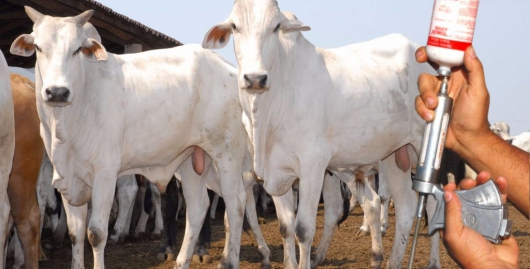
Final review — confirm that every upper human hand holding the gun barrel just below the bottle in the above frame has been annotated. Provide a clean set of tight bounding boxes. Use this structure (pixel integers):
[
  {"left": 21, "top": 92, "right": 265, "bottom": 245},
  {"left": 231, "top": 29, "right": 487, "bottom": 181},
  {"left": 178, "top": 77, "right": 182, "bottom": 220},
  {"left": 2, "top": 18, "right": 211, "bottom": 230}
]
[{"left": 416, "top": 46, "right": 493, "bottom": 156}]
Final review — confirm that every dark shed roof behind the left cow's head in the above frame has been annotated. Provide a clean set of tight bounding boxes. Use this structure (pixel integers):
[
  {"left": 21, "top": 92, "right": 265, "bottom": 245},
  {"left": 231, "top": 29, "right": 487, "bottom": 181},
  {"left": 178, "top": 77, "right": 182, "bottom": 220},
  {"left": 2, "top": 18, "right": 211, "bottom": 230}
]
[{"left": 0, "top": 0, "right": 182, "bottom": 68}]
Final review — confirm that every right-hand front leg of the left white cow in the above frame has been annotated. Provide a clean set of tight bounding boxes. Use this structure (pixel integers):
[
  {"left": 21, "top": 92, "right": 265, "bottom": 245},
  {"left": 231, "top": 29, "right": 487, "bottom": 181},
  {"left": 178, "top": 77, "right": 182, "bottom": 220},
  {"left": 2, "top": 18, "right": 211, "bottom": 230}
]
[{"left": 87, "top": 173, "right": 116, "bottom": 269}]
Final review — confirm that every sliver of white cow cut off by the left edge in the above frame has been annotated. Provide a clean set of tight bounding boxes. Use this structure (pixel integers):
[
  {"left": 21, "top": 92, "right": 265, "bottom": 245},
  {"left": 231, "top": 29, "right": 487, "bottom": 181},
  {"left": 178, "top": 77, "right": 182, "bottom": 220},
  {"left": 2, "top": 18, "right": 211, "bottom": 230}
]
[{"left": 0, "top": 49, "right": 15, "bottom": 268}]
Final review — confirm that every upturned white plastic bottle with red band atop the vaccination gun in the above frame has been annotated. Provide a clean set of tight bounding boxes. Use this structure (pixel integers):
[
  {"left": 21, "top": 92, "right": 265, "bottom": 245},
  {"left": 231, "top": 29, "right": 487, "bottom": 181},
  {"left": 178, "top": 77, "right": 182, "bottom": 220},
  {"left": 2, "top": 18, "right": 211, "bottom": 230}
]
[{"left": 427, "top": 0, "right": 479, "bottom": 74}]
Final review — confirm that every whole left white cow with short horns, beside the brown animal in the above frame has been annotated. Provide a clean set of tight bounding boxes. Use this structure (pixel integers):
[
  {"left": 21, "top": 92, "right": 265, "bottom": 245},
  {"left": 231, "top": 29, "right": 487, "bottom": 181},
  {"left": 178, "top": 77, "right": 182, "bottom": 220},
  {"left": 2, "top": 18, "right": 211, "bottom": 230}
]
[{"left": 11, "top": 7, "right": 247, "bottom": 268}]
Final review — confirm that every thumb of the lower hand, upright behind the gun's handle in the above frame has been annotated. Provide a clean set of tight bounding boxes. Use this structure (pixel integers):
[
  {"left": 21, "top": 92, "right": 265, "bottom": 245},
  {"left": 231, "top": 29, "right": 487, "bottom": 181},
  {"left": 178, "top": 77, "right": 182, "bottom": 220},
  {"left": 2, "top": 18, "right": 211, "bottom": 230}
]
[{"left": 444, "top": 189, "right": 464, "bottom": 242}]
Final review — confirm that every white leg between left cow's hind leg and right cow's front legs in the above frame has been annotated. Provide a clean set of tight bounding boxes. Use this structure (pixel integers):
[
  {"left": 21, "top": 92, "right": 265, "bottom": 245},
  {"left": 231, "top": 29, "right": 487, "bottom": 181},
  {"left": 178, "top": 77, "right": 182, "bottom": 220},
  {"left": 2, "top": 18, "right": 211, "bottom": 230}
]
[{"left": 245, "top": 181, "right": 271, "bottom": 269}]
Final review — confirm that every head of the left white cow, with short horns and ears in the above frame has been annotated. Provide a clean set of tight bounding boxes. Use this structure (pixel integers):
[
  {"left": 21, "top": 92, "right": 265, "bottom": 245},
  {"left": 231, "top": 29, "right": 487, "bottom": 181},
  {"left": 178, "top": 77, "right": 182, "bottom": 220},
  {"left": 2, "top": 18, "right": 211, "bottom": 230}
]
[{"left": 11, "top": 6, "right": 107, "bottom": 106}]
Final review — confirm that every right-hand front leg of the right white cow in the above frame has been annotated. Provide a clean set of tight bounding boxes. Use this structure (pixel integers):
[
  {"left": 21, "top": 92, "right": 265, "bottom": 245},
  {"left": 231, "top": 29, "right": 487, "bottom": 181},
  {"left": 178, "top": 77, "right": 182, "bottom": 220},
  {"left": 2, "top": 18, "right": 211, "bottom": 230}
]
[{"left": 295, "top": 165, "right": 326, "bottom": 268}]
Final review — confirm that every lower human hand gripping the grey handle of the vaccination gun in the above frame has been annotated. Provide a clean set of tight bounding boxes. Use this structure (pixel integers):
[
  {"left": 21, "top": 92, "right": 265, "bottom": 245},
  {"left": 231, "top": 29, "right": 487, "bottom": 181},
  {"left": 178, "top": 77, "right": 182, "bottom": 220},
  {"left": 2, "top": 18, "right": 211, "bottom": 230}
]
[{"left": 440, "top": 172, "right": 519, "bottom": 269}]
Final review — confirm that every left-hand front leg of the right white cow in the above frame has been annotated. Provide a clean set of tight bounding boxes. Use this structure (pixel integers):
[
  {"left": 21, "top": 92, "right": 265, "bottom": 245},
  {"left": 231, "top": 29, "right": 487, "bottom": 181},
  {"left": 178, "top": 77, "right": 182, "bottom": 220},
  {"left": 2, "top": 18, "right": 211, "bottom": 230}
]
[{"left": 272, "top": 188, "right": 298, "bottom": 269}]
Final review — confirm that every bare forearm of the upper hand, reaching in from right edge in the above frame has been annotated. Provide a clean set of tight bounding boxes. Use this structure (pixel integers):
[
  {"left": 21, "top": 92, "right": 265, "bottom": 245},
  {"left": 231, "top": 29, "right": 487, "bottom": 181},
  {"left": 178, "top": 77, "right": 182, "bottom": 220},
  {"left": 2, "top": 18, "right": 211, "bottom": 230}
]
[{"left": 455, "top": 132, "right": 530, "bottom": 218}]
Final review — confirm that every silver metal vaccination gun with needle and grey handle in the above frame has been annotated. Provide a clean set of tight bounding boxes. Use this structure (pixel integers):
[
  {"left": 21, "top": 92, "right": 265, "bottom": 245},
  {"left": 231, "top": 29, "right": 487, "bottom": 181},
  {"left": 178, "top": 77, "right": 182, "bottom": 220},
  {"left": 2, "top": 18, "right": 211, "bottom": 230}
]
[{"left": 409, "top": 69, "right": 511, "bottom": 268}]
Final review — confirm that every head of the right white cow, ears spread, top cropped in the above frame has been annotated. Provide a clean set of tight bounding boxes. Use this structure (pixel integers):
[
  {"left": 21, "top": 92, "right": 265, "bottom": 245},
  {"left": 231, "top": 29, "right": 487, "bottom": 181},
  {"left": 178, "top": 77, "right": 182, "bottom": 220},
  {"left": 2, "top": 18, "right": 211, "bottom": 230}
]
[{"left": 202, "top": 0, "right": 310, "bottom": 93}]
